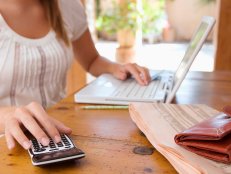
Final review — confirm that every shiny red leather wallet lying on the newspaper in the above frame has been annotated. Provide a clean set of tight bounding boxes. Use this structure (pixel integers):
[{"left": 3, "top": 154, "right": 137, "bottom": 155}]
[{"left": 174, "top": 106, "right": 231, "bottom": 163}]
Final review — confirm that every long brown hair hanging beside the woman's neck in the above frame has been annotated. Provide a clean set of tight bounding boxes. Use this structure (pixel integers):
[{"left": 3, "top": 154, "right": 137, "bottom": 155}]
[{"left": 41, "top": 0, "right": 70, "bottom": 46}]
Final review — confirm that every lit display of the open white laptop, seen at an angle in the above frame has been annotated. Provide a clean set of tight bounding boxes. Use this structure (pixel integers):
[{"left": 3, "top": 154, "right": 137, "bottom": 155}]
[{"left": 173, "top": 22, "right": 208, "bottom": 84}]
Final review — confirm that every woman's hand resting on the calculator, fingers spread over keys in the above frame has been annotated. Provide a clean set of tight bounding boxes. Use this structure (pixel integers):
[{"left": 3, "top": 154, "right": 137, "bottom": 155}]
[{"left": 3, "top": 102, "right": 71, "bottom": 149}]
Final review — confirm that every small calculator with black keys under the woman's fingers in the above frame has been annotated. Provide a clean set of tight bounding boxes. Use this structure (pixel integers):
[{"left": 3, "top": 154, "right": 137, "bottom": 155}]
[{"left": 28, "top": 134, "right": 85, "bottom": 166}]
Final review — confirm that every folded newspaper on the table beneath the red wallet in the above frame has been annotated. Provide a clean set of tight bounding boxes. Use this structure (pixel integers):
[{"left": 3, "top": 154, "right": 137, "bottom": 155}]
[{"left": 129, "top": 103, "right": 231, "bottom": 174}]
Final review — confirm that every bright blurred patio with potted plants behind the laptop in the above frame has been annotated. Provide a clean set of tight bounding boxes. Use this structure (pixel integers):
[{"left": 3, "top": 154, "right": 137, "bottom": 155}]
[{"left": 68, "top": 0, "right": 222, "bottom": 94}]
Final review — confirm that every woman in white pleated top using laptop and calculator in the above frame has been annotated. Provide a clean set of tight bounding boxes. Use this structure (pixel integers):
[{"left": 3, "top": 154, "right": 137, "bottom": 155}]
[{"left": 0, "top": 0, "right": 150, "bottom": 149}]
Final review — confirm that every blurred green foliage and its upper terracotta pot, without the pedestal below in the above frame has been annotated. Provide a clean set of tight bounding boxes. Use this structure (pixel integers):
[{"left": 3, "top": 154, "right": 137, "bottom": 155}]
[{"left": 96, "top": 0, "right": 141, "bottom": 47}]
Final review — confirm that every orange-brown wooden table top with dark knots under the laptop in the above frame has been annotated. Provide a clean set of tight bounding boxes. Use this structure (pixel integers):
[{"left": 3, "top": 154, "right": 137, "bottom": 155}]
[{"left": 0, "top": 72, "right": 231, "bottom": 174}]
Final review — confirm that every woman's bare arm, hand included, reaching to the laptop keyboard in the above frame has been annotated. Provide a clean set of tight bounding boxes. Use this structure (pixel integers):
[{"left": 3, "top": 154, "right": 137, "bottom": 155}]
[{"left": 72, "top": 30, "right": 150, "bottom": 85}]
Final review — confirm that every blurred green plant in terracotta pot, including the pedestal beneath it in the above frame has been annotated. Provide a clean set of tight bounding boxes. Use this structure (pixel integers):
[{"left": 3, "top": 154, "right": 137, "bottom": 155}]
[{"left": 96, "top": 0, "right": 141, "bottom": 63}]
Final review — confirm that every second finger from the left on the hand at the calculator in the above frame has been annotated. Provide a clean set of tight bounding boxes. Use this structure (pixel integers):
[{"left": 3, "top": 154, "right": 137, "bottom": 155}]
[{"left": 7, "top": 119, "right": 31, "bottom": 150}]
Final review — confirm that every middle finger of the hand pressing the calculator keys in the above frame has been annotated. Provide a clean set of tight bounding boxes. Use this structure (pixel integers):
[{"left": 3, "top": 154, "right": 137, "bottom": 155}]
[{"left": 15, "top": 108, "right": 49, "bottom": 146}]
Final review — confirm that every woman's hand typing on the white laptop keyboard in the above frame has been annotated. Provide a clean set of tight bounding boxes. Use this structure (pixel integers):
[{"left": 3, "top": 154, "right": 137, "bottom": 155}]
[{"left": 112, "top": 63, "right": 151, "bottom": 85}]
